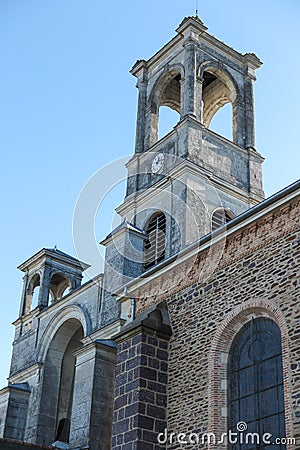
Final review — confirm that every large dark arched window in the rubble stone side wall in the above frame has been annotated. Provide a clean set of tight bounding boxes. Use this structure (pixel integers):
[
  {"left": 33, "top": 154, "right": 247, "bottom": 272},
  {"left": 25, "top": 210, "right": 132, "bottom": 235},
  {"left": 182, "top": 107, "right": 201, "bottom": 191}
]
[{"left": 228, "top": 318, "right": 286, "bottom": 450}]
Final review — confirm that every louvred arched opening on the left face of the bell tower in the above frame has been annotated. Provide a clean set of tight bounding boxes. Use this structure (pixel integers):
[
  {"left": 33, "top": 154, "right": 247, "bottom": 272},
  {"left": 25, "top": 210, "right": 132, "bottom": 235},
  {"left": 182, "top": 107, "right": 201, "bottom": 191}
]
[{"left": 144, "top": 213, "right": 166, "bottom": 270}]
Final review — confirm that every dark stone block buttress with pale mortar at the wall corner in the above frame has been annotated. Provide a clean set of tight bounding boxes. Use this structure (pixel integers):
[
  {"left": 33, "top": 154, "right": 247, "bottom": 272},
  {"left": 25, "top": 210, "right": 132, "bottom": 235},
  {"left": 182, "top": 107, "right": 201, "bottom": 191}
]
[{"left": 111, "top": 306, "right": 171, "bottom": 450}]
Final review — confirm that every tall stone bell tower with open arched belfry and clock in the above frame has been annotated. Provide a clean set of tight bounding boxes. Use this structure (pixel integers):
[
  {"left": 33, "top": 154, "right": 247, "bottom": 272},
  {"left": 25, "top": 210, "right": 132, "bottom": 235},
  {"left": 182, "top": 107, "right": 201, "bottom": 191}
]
[{"left": 112, "top": 16, "right": 264, "bottom": 270}]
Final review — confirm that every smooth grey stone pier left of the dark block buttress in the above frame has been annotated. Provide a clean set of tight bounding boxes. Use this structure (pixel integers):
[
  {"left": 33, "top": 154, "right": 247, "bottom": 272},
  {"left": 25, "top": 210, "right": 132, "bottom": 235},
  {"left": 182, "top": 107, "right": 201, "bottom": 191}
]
[{"left": 70, "top": 340, "right": 117, "bottom": 450}]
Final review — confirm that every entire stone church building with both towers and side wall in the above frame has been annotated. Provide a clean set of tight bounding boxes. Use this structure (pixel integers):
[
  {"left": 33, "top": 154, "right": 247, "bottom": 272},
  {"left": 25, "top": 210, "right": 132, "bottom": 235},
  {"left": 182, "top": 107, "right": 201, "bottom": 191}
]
[{"left": 0, "top": 12, "right": 300, "bottom": 450}]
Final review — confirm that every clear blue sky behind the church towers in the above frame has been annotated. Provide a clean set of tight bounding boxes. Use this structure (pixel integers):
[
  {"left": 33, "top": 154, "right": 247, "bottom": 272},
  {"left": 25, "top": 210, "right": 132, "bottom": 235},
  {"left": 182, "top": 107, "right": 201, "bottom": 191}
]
[{"left": 0, "top": 0, "right": 300, "bottom": 386}]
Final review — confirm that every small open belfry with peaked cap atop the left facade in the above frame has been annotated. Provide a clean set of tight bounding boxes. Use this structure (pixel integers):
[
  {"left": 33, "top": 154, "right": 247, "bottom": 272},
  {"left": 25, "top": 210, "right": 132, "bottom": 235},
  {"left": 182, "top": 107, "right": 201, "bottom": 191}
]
[{"left": 18, "top": 247, "right": 89, "bottom": 317}]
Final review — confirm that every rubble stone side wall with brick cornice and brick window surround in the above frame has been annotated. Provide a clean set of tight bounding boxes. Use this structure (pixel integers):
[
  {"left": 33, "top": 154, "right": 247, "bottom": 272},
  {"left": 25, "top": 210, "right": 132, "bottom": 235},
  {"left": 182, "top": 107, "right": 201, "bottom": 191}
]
[{"left": 127, "top": 197, "right": 300, "bottom": 449}]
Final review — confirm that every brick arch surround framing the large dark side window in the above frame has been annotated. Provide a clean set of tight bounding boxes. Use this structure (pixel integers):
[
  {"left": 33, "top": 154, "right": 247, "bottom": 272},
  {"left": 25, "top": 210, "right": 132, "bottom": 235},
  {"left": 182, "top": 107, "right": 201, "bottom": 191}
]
[{"left": 208, "top": 299, "right": 293, "bottom": 449}]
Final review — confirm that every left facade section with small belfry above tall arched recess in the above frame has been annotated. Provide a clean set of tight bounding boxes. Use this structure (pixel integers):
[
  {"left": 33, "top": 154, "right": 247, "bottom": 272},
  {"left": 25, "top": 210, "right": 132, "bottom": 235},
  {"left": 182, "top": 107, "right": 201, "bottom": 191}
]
[{"left": 0, "top": 247, "right": 89, "bottom": 444}]
